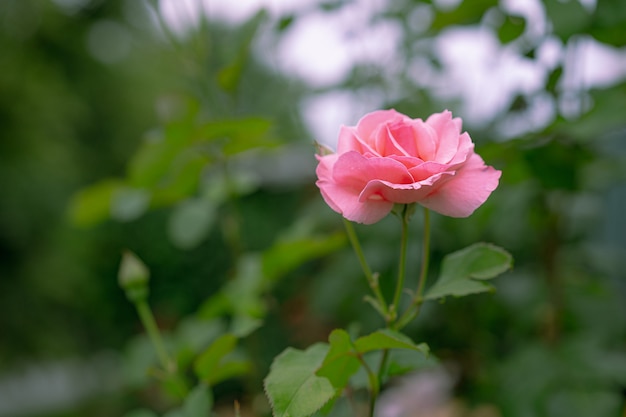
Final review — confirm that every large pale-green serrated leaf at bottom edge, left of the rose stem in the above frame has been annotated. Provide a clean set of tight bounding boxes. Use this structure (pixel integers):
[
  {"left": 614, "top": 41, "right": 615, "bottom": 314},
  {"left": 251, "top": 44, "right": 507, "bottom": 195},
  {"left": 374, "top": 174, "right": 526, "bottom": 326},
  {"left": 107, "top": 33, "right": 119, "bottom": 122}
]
[{"left": 264, "top": 343, "right": 335, "bottom": 417}]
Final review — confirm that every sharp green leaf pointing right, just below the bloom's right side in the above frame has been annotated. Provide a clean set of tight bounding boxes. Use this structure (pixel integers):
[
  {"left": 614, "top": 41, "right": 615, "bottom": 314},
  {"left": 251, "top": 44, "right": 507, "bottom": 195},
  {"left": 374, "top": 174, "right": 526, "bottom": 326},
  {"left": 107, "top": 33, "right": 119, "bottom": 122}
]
[{"left": 424, "top": 243, "right": 513, "bottom": 300}]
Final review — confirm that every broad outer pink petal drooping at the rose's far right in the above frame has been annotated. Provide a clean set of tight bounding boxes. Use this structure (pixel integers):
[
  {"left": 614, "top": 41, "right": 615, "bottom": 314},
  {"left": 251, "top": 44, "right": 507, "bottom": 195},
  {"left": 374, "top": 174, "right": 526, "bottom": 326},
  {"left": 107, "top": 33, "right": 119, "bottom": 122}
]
[{"left": 419, "top": 154, "right": 502, "bottom": 217}]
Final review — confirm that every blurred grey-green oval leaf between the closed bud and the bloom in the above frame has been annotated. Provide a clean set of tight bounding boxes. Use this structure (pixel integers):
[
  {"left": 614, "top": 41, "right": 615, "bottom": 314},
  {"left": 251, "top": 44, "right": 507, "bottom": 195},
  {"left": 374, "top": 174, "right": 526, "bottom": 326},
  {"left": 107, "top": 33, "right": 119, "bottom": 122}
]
[{"left": 168, "top": 199, "right": 217, "bottom": 249}]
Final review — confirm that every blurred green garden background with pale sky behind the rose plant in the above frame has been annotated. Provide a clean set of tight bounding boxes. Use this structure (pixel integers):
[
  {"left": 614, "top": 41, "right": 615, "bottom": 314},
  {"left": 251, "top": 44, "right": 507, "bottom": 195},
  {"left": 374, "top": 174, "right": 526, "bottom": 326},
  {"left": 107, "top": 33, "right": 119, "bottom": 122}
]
[{"left": 0, "top": 0, "right": 626, "bottom": 417}]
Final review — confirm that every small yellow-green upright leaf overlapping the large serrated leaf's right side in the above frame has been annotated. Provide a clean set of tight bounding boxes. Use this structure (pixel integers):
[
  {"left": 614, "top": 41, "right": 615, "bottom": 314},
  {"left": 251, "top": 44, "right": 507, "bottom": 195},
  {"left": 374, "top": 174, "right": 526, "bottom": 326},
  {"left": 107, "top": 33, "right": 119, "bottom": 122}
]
[{"left": 316, "top": 329, "right": 361, "bottom": 390}]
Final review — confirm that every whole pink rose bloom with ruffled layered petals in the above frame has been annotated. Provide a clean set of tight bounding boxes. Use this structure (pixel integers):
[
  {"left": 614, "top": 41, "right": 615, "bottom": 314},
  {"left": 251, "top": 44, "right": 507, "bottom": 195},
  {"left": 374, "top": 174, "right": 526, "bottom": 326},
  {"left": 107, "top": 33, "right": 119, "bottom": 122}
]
[{"left": 316, "top": 110, "right": 501, "bottom": 224}]
